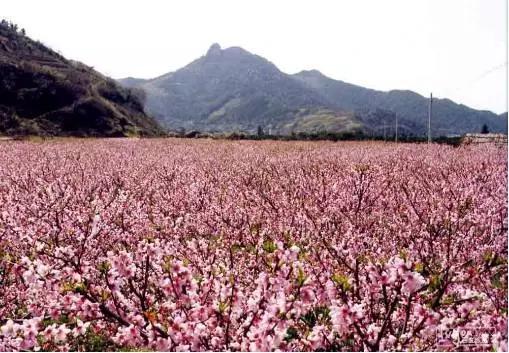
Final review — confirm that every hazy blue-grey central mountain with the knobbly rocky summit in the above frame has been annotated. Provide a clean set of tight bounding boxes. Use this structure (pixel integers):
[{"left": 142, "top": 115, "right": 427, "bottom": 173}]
[{"left": 120, "top": 44, "right": 361, "bottom": 134}]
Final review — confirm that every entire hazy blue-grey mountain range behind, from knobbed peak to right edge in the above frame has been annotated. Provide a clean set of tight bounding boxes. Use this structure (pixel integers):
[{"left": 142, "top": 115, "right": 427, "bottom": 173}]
[{"left": 120, "top": 44, "right": 507, "bottom": 136}]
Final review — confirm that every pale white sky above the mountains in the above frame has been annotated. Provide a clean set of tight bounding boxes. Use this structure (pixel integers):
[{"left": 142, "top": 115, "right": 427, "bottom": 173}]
[{"left": 0, "top": 0, "right": 507, "bottom": 113}]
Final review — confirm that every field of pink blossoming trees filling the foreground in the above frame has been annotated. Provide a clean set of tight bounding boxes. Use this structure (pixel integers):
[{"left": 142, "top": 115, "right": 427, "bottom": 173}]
[{"left": 0, "top": 139, "right": 508, "bottom": 351}]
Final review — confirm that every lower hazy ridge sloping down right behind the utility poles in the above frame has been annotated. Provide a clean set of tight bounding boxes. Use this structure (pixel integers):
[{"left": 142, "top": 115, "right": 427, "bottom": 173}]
[{"left": 293, "top": 70, "right": 507, "bottom": 136}]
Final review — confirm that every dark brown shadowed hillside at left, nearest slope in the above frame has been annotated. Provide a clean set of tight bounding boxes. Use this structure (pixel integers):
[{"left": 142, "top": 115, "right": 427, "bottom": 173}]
[{"left": 0, "top": 20, "right": 162, "bottom": 136}]
